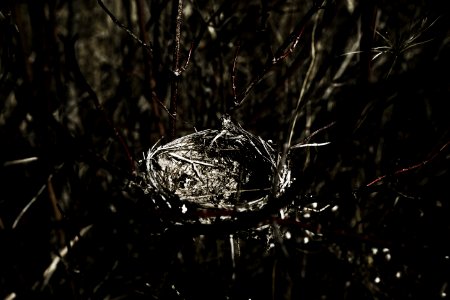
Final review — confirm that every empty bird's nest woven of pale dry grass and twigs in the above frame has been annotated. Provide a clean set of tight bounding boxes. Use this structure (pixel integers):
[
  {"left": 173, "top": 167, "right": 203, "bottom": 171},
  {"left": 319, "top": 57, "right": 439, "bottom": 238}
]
[{"left": 146, "top": 116, "right": 287, "bottom": 210}]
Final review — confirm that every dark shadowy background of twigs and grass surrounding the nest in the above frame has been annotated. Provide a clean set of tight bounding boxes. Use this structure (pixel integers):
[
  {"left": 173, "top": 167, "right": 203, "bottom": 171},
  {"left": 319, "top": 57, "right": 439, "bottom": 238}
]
[{"left": 0, "top": 0, "right": 450, "bottom": 299}]
